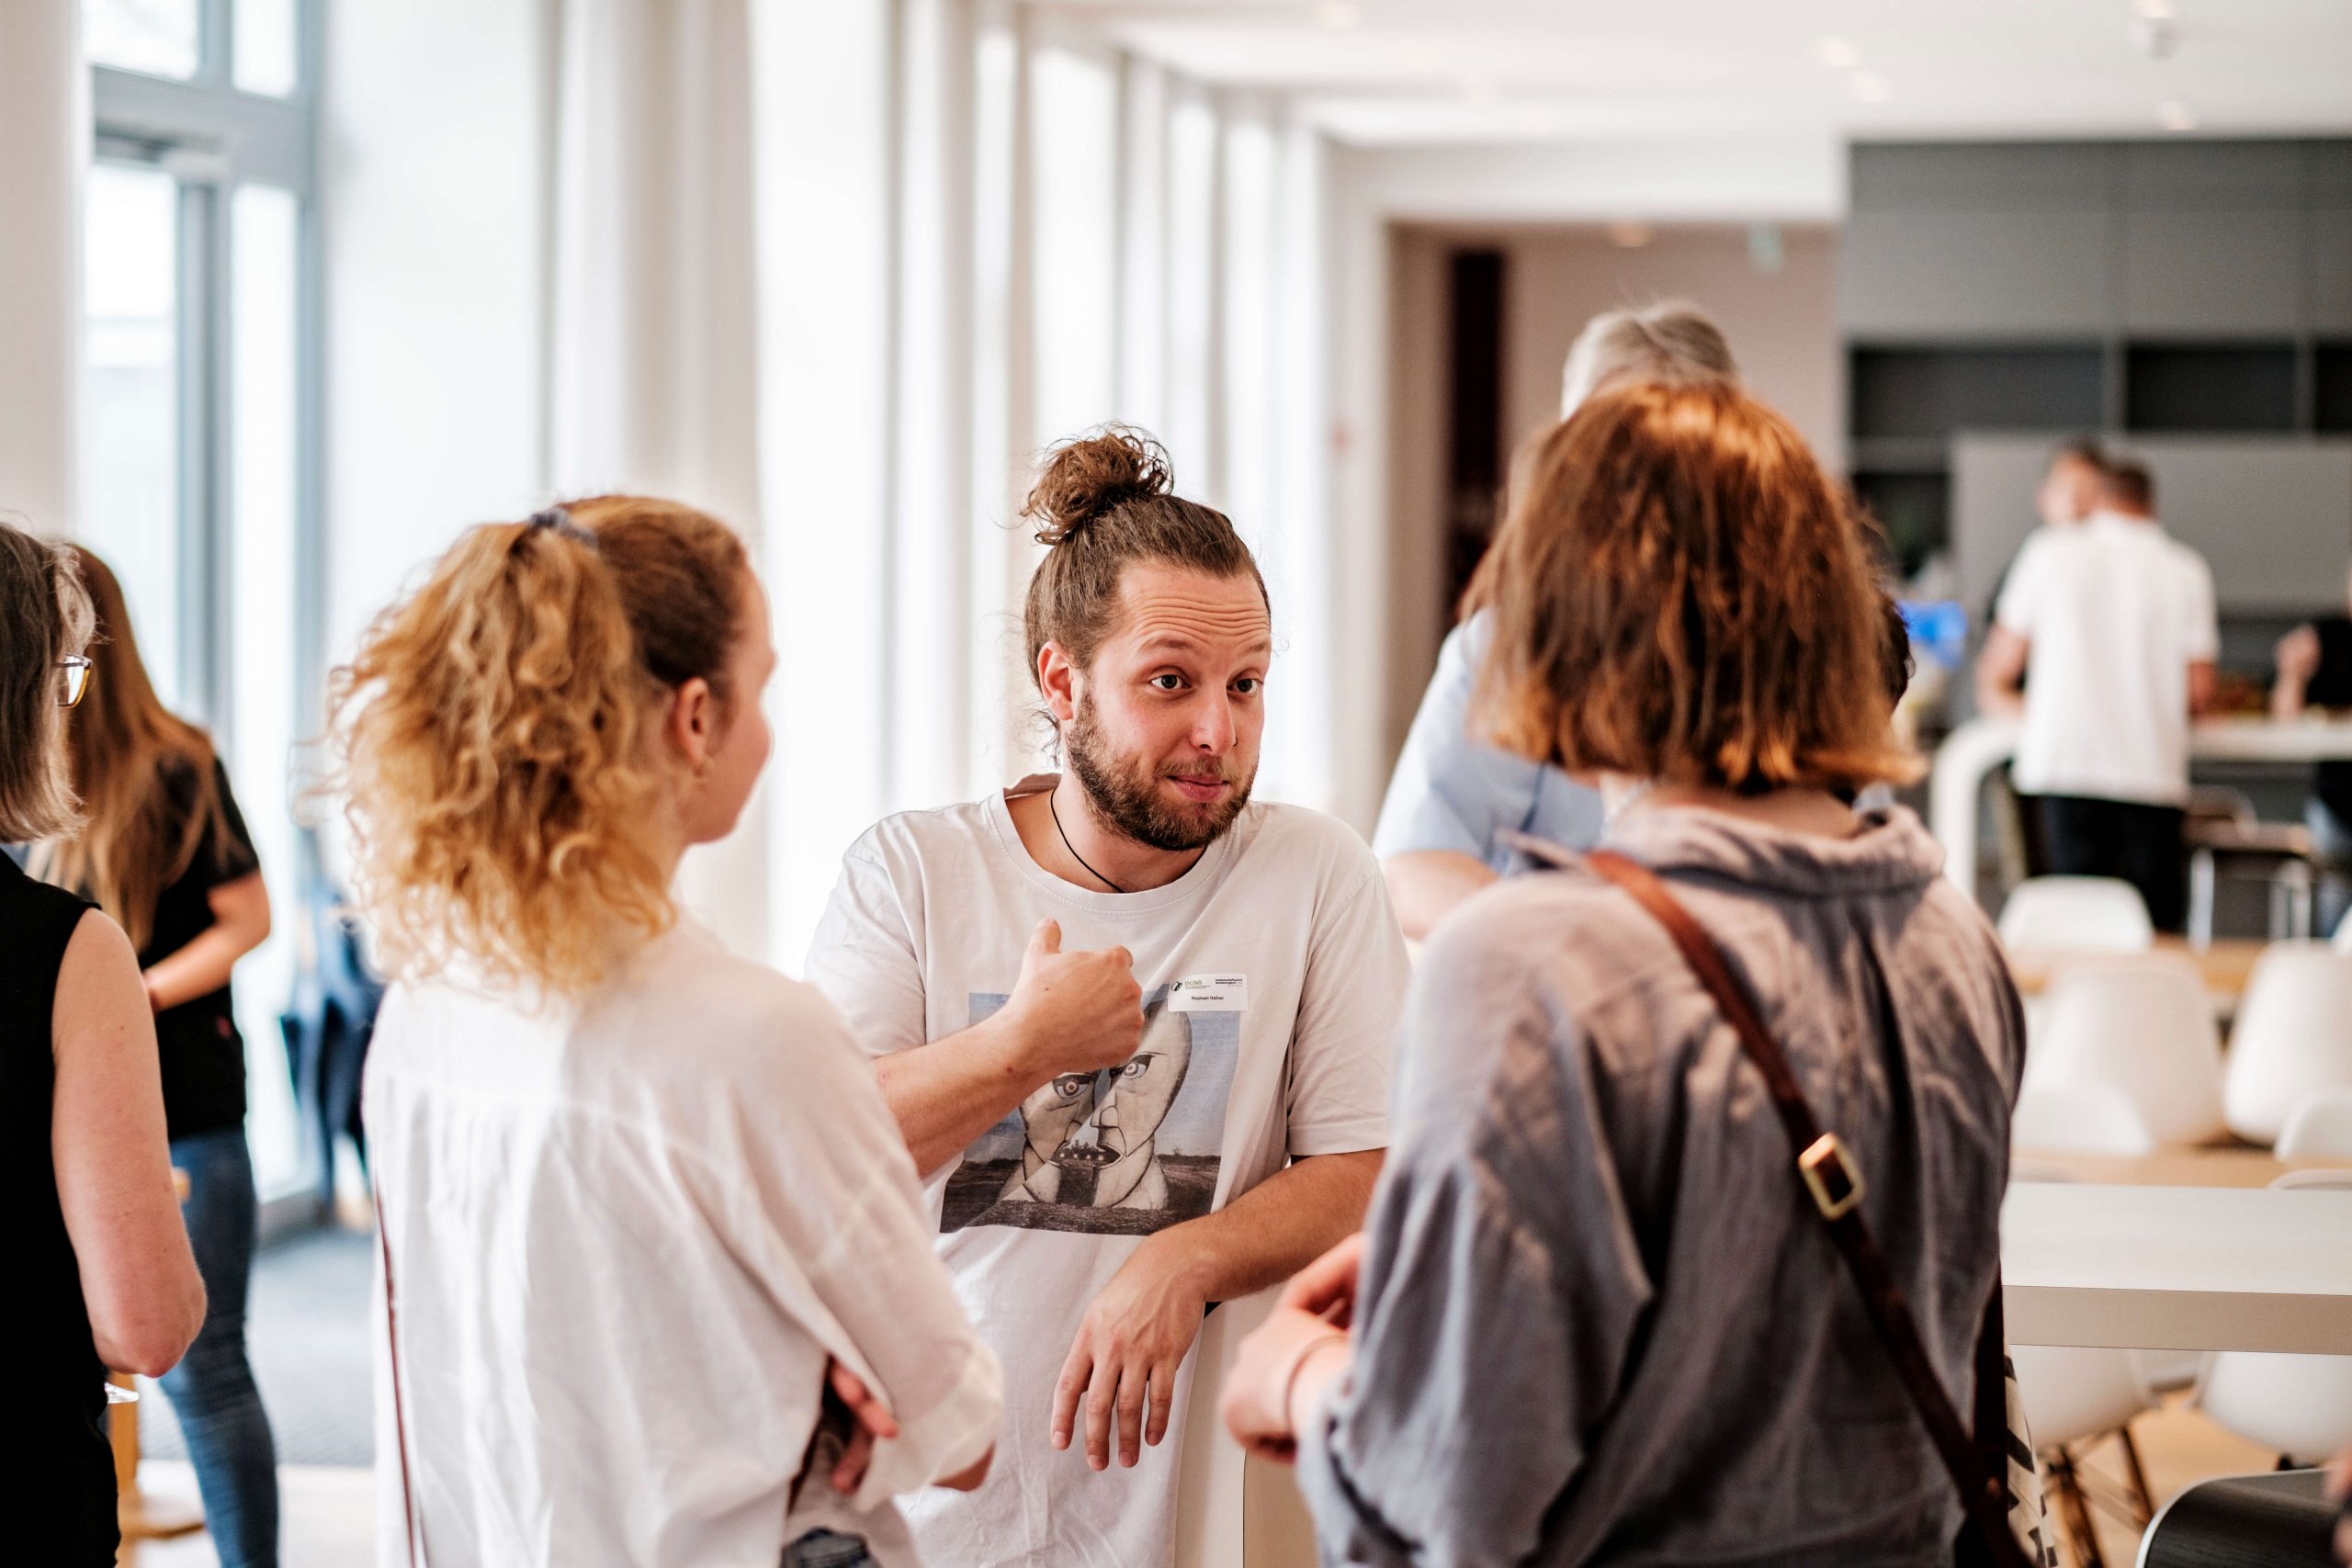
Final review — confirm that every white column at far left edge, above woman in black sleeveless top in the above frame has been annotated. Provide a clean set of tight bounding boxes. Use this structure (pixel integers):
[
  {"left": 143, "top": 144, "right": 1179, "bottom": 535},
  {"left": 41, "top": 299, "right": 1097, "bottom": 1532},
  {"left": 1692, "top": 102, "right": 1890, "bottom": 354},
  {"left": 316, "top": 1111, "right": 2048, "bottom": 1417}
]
[{"left": 0, "top": 0, "right": 89, "bottom": 534}]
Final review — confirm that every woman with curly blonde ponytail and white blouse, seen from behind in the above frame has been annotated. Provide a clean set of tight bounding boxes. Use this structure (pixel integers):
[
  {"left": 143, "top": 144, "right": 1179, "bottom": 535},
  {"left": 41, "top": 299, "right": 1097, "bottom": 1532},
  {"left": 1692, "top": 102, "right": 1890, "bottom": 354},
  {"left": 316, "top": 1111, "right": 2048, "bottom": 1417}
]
[{"left": 334, "top": 496, "right": 1000, "bottom": 1568}]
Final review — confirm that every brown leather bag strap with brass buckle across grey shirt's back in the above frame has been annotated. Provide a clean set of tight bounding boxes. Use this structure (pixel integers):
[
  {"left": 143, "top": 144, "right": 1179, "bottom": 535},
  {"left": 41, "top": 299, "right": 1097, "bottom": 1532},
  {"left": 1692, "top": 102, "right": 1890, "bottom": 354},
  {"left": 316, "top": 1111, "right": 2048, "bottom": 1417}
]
[{"left": 1585, "top": 849, "right": 2030, "bottom": 1568}]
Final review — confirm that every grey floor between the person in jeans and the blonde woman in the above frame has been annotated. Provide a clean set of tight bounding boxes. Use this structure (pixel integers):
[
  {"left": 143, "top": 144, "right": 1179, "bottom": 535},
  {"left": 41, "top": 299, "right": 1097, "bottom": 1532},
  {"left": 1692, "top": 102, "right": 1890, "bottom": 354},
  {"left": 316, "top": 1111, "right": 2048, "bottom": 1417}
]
[{"left": 139, "top": 1229, "right": 377, "bottom": 1464}]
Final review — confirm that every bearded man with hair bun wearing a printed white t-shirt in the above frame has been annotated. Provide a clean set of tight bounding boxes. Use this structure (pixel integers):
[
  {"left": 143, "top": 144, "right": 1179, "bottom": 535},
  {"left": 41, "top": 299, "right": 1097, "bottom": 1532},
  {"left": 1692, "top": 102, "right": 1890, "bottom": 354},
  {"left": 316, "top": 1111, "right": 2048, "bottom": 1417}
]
[{"left": 809, "top": 428, "right": 1407, "bottom": 1568}]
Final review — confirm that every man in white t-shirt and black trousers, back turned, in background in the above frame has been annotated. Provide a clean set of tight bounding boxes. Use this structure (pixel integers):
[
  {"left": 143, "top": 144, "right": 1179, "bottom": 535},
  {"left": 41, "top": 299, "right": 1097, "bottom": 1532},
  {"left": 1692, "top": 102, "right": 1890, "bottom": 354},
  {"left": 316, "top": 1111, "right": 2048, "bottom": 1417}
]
[{"left": 1975, "top": 463, "right": 2221, "bottom": 931}]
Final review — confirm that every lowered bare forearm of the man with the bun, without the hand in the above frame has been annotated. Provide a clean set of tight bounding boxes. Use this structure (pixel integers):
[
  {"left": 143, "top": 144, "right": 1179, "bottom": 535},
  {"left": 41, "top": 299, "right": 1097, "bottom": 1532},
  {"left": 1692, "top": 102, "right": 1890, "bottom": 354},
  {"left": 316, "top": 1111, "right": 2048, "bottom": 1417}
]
[{"left": 1152, "top": 1149, "right": 1383, "bottom": 1303}]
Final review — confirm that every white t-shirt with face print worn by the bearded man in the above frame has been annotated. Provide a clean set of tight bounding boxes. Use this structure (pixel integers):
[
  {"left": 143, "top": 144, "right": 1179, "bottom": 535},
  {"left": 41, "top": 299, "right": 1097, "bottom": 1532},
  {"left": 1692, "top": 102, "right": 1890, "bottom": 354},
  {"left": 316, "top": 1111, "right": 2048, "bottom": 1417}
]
[{"left": 809, "top": 776, "right": 1407, "bottom": 1568}]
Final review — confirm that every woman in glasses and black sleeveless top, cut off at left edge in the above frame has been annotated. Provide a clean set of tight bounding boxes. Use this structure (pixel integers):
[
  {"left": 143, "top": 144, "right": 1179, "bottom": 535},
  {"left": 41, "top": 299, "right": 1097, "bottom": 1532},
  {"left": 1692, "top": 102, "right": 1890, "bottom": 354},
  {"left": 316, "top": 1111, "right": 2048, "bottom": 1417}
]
[{"left": 0, "top": 522, "right": 205, "bottom": 1568}]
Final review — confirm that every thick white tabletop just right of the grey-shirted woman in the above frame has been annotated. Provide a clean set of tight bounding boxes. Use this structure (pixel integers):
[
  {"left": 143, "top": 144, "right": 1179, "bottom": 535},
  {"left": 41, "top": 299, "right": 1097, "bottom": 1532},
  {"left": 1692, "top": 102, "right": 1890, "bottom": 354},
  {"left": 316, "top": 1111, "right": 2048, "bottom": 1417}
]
[{"left": 2002, "top": 1182, "right": 2352, "bottom": 1357}]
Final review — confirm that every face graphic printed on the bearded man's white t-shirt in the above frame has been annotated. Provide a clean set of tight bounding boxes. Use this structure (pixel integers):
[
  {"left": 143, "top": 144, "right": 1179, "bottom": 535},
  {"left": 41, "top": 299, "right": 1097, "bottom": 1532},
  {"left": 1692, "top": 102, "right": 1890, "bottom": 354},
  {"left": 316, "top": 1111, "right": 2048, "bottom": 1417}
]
[{"left": 941, "top": 987, "right": 1242, "bottom": 1236}]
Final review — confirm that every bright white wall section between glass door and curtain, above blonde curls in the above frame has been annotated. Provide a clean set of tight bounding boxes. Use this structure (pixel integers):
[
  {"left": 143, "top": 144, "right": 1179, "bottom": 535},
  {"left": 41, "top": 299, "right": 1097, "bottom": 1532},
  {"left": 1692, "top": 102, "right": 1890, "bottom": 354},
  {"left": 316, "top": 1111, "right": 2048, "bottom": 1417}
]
[{"left": 320, "top": 0, "right": 548, "bottom": 660}]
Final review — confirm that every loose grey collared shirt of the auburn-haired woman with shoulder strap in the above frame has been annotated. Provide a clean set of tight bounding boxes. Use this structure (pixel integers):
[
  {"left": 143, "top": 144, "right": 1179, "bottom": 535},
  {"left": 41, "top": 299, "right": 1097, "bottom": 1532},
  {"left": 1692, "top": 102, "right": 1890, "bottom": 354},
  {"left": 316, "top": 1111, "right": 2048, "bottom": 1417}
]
[{"left": 1298, "top": 807, "right": 2025, "bottom": 1568}]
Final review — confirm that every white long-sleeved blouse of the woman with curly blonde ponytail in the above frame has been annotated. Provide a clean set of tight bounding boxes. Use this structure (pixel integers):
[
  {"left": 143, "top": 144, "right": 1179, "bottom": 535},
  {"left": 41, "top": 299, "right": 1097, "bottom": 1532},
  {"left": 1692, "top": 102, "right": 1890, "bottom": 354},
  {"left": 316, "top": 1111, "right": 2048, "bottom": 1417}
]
[{"left": 367, "top": 921, "right": 1002, "bottom": 1568}]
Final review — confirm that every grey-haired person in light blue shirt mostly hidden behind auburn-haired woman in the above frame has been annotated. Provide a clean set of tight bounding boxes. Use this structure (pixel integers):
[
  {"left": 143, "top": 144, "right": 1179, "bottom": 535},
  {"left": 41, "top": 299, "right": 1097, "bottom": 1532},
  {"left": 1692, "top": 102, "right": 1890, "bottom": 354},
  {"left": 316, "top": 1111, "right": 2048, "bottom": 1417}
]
[{"left": 1371, "top": 301, "right": 1738, "bottom": 941}]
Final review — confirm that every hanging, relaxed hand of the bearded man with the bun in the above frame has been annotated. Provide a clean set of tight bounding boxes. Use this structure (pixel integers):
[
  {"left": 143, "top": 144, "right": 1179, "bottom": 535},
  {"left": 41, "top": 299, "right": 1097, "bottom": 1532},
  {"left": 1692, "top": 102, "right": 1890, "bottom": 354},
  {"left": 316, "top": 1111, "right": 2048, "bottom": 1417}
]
[{"left": 1054, "top": 1232, "right": 1209, "bottom": 1470}]
